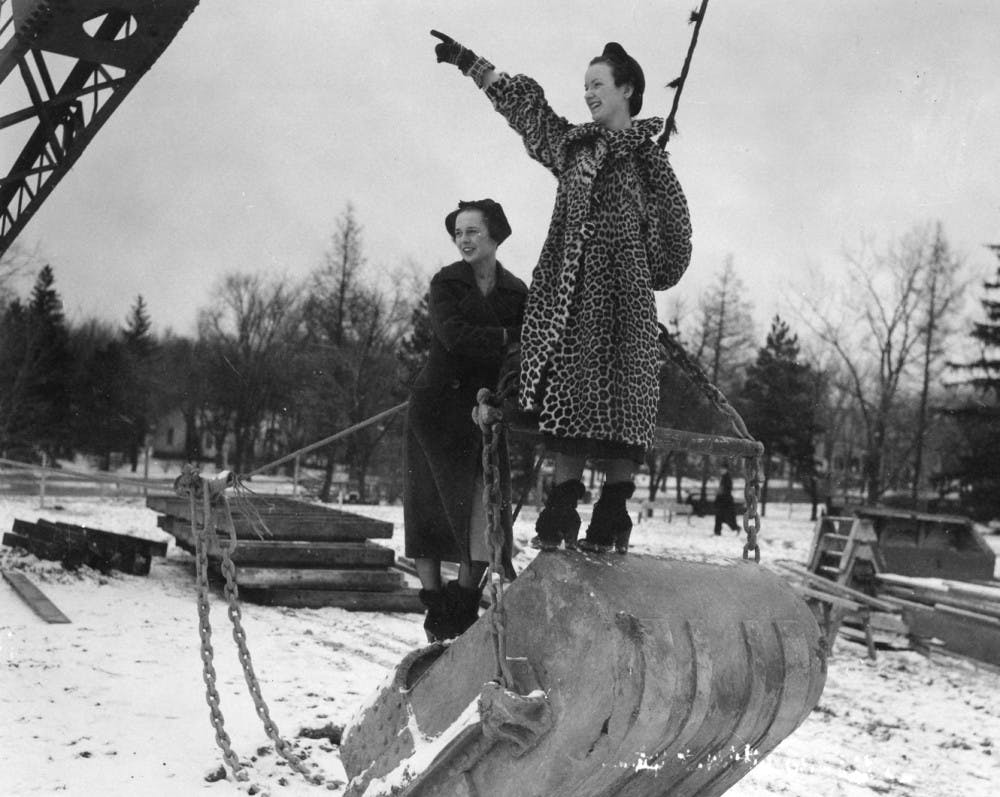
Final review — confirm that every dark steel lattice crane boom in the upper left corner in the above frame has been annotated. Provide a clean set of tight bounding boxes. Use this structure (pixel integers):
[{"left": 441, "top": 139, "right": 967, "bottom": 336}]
[{"left": 0, "top": 0, "right": 198, "bottom": 255}]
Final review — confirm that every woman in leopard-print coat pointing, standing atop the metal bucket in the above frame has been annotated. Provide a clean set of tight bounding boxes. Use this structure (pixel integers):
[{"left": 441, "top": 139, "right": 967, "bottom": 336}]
[{"left": 431, "top": 31, "right": 691, "bottom": 553}]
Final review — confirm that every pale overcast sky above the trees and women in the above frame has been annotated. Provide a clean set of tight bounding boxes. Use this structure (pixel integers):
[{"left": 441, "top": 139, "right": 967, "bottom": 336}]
[{"left": 2, "top": 0, "right": 1000, "bottom": 334}]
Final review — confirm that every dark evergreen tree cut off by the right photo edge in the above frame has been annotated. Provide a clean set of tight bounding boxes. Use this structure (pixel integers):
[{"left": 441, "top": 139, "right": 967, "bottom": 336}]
[{"left": 950, "top": 244, "right": 1000, "bottom": 521}]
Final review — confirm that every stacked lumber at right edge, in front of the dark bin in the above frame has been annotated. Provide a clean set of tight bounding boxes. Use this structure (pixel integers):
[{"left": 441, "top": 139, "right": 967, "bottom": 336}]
[{"left": 876, "top": 573, "right": 1000, "bottom": 665}]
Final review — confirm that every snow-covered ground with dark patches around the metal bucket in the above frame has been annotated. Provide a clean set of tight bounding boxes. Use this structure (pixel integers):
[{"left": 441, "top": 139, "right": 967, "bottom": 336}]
[{"left": 0, "top": 495, "right": 1000, "bottom": 797}]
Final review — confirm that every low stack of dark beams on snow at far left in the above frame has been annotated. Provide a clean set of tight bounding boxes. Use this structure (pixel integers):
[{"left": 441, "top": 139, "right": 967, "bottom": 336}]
[{"left": 3, "top": 519, "right": 167, "bottom": 576}]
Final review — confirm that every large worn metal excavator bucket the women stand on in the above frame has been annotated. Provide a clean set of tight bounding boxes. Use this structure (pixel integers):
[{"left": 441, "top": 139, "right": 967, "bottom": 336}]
[{"left": 341, "top": 552, "right": 826, "bottom": 797}]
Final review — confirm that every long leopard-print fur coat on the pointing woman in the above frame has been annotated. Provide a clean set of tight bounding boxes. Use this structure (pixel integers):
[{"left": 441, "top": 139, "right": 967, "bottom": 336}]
[{"left": 487, "top": 74, "right": 691, "bottom": 455}]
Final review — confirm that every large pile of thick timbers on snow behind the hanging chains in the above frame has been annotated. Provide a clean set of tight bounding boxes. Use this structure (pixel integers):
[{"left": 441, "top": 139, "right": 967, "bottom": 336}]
[{"left": 146, "top": 495, "right": 423, "bottom": 612}]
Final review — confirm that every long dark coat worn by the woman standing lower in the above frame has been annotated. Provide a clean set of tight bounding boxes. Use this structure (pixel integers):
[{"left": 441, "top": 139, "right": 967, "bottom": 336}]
[{"left": 403, "top": 261, "right": 528, "bottom": 575}]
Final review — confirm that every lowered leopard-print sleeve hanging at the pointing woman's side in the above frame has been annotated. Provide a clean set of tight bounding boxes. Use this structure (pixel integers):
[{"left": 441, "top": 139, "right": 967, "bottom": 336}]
[{"left": 643, "top": 142, "right": 691, "bottom": 291}]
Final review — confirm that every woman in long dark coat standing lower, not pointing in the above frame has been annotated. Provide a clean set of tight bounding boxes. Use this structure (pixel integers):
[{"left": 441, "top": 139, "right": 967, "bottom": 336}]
[{"left": 403, "top": 199, "right": 528, "bottom": 641}]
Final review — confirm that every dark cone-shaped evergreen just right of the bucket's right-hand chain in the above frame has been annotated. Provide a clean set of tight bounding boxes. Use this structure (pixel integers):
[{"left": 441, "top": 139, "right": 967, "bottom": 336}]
[{"left": 739, "top": 316, "right": 820, "bottom": 511}]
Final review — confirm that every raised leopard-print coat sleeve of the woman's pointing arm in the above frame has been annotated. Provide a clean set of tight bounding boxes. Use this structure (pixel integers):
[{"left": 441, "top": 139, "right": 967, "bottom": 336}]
[{"left": 486, "top": 74, "right": 572, "bottom": 177}]
